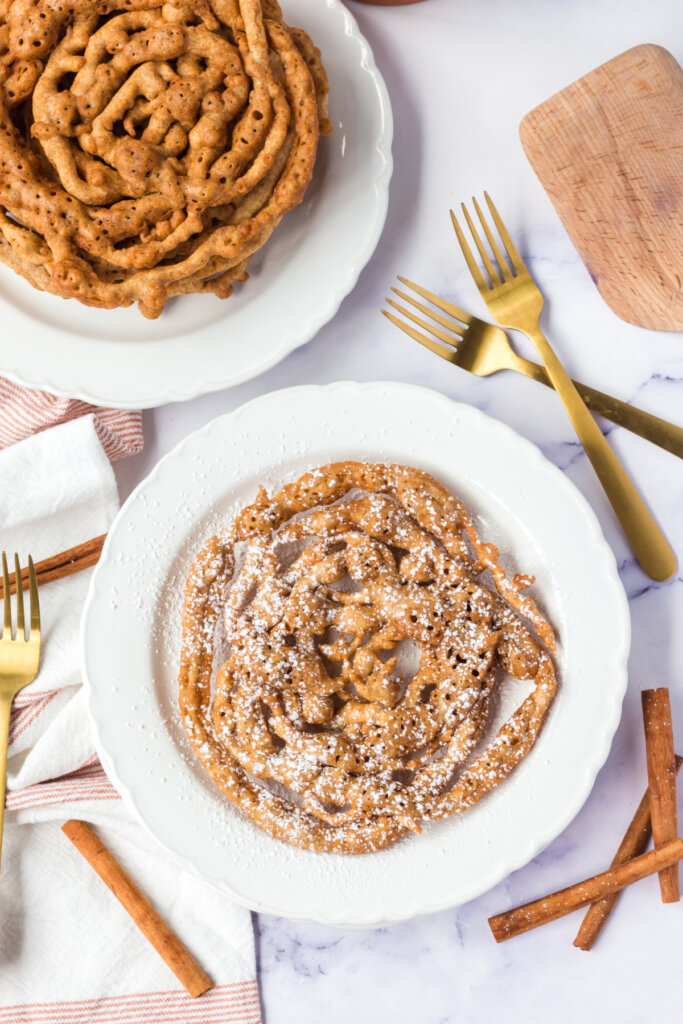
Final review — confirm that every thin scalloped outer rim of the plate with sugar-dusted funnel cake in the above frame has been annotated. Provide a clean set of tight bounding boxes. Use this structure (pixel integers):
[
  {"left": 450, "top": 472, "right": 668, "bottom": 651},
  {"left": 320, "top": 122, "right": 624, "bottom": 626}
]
[{"left": 80, "top": 380, "right": 631, "bottom": 929}]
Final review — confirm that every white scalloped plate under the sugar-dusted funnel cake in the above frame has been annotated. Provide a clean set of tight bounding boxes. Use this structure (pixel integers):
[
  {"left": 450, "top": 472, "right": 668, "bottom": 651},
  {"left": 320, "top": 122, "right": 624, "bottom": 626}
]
[{"left": 83, "top": 384, "right": 630, "bottom": 927}]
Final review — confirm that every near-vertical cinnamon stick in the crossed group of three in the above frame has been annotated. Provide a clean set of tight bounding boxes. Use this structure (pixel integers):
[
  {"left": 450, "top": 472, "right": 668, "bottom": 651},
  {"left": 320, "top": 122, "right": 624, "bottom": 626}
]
[{"left": 641, "top": 687, "right": 681, "bottom": 903}]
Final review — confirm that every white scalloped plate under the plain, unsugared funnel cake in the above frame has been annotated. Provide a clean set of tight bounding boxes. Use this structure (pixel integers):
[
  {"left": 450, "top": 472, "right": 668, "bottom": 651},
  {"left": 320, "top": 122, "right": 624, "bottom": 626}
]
[{"left": 0, "top": 0, "right": 392, "bottom": 409}]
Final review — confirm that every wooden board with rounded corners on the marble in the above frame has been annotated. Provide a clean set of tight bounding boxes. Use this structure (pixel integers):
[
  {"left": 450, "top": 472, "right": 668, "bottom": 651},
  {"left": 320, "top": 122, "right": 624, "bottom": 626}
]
[{"left": 520, "top": 44, "right": 683, "bottom": 331}]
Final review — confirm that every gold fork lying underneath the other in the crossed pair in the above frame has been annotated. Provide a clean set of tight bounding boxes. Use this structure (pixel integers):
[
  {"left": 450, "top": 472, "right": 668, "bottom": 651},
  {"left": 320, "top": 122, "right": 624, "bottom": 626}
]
[{"left": 382, "top": 275, "right": 683, "bottom": 459}]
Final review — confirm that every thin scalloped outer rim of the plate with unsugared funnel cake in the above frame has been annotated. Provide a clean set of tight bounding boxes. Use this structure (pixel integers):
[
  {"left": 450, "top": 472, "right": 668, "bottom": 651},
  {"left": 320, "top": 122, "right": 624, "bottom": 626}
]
[{"left": 1, "top": 0, "right": 393, "bottom": 410}]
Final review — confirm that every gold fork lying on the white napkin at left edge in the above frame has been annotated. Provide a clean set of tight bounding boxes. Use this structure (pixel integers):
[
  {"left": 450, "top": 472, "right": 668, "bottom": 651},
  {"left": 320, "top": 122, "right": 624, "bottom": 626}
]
[{"left": 0, "top": 551, "right": 40, "bottom": 858}]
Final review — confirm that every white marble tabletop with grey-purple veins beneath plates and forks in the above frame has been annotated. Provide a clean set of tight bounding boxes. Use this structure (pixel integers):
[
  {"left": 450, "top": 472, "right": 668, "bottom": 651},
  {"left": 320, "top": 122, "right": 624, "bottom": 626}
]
[{"left": 113, "top": 0, "right": 683, "bottom": 1024}]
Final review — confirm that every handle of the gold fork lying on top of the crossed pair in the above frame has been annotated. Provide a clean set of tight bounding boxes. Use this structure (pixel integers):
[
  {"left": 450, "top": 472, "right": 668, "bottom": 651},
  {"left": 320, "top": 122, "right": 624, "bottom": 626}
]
[{"left": 526, "top": 328, "right": 676, "bottom": 580}]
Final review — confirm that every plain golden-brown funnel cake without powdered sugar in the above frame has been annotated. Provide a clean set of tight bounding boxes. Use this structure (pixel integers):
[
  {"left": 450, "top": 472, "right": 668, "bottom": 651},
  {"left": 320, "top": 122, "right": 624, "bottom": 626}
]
[{"left": 0, "top": 0, "right": 331, "bottom": 317}]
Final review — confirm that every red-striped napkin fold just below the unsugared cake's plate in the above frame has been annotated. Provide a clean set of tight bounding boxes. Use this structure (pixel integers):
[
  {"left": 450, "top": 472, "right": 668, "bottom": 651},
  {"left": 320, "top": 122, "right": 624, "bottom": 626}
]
[{"left": 0, "top": 377, "right": 142, "bottom": 462}]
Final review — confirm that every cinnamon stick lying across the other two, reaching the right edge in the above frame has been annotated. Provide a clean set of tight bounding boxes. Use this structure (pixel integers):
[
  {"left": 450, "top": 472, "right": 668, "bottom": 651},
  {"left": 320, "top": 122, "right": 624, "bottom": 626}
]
[{"left": 488, "top": 839, "right": 683, "bottom": 942}]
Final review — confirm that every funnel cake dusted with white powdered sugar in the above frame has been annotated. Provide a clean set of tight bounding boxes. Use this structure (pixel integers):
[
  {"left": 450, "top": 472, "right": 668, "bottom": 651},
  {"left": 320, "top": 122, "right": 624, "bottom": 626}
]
[{"left": 179, "top": 462, "right": 556, "bottom": 854}]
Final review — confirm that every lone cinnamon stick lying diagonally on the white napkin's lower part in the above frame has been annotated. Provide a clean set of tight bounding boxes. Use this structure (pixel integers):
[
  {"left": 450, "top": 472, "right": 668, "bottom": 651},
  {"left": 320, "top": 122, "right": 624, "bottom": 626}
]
[{"left": 61, "top": 819, "right": 213, "bottom": 997}]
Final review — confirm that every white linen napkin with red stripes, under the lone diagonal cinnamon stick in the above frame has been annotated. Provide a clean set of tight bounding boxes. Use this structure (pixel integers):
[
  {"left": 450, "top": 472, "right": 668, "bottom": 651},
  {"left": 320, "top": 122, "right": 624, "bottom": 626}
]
[{"left": 0, "top": 416, "right": 261, "bottom": 1024}]
